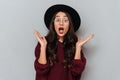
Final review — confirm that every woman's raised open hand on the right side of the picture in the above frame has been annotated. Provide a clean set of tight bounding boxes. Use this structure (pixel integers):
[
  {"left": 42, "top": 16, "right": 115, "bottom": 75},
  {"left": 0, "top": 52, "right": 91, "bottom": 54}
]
[{"left": 76, "top": 34, "right": 94, "bottom": 47}]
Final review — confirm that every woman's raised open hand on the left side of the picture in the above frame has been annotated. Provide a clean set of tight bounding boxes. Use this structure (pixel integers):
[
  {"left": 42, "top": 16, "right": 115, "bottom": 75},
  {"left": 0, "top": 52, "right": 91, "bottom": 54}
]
[{"left": 34, "top": 30, "right": 47, "bottom": 48}]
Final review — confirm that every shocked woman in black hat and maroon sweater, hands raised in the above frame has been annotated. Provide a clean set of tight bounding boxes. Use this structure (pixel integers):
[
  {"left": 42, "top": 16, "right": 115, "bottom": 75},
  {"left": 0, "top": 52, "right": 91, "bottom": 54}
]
[{"left": 34, "top": 4, "right": 93, "bottom": 80}]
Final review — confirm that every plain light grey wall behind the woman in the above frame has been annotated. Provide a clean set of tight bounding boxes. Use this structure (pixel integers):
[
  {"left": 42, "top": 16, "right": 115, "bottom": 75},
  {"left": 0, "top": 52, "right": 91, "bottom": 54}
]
[{"left": 0, "top": 0, "right": 120, "bottom": 80}]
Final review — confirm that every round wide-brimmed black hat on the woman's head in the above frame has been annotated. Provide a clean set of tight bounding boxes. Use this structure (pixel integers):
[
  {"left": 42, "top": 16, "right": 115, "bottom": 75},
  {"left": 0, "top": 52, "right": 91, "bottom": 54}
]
[{"left": 44, "top": 4, "right": 81, "bottom": 32}]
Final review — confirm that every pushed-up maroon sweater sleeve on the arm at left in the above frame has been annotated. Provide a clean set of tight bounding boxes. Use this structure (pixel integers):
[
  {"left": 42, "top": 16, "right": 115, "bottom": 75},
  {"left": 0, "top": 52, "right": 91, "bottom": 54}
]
[{"left": 34, "top": 43, "right": 49, "bottom": 75}]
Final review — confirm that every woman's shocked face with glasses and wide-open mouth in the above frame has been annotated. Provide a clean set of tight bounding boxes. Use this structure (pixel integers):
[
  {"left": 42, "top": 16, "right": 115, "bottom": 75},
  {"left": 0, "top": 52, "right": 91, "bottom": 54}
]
[{"left": 54, "top": 12, "right": 69, "bottom": 38}]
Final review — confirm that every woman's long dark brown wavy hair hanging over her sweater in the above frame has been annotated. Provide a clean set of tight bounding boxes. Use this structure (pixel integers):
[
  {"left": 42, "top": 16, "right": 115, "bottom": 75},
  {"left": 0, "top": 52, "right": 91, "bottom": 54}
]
[{"left": 46, "top": 11, "right": 78, "bottom": 68}]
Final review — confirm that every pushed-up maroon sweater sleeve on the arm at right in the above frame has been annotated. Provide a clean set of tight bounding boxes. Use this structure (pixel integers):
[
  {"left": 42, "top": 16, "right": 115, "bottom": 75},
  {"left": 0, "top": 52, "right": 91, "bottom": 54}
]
[{"left": 70, "top": 51, "right": 86, "bottom": 76}]
